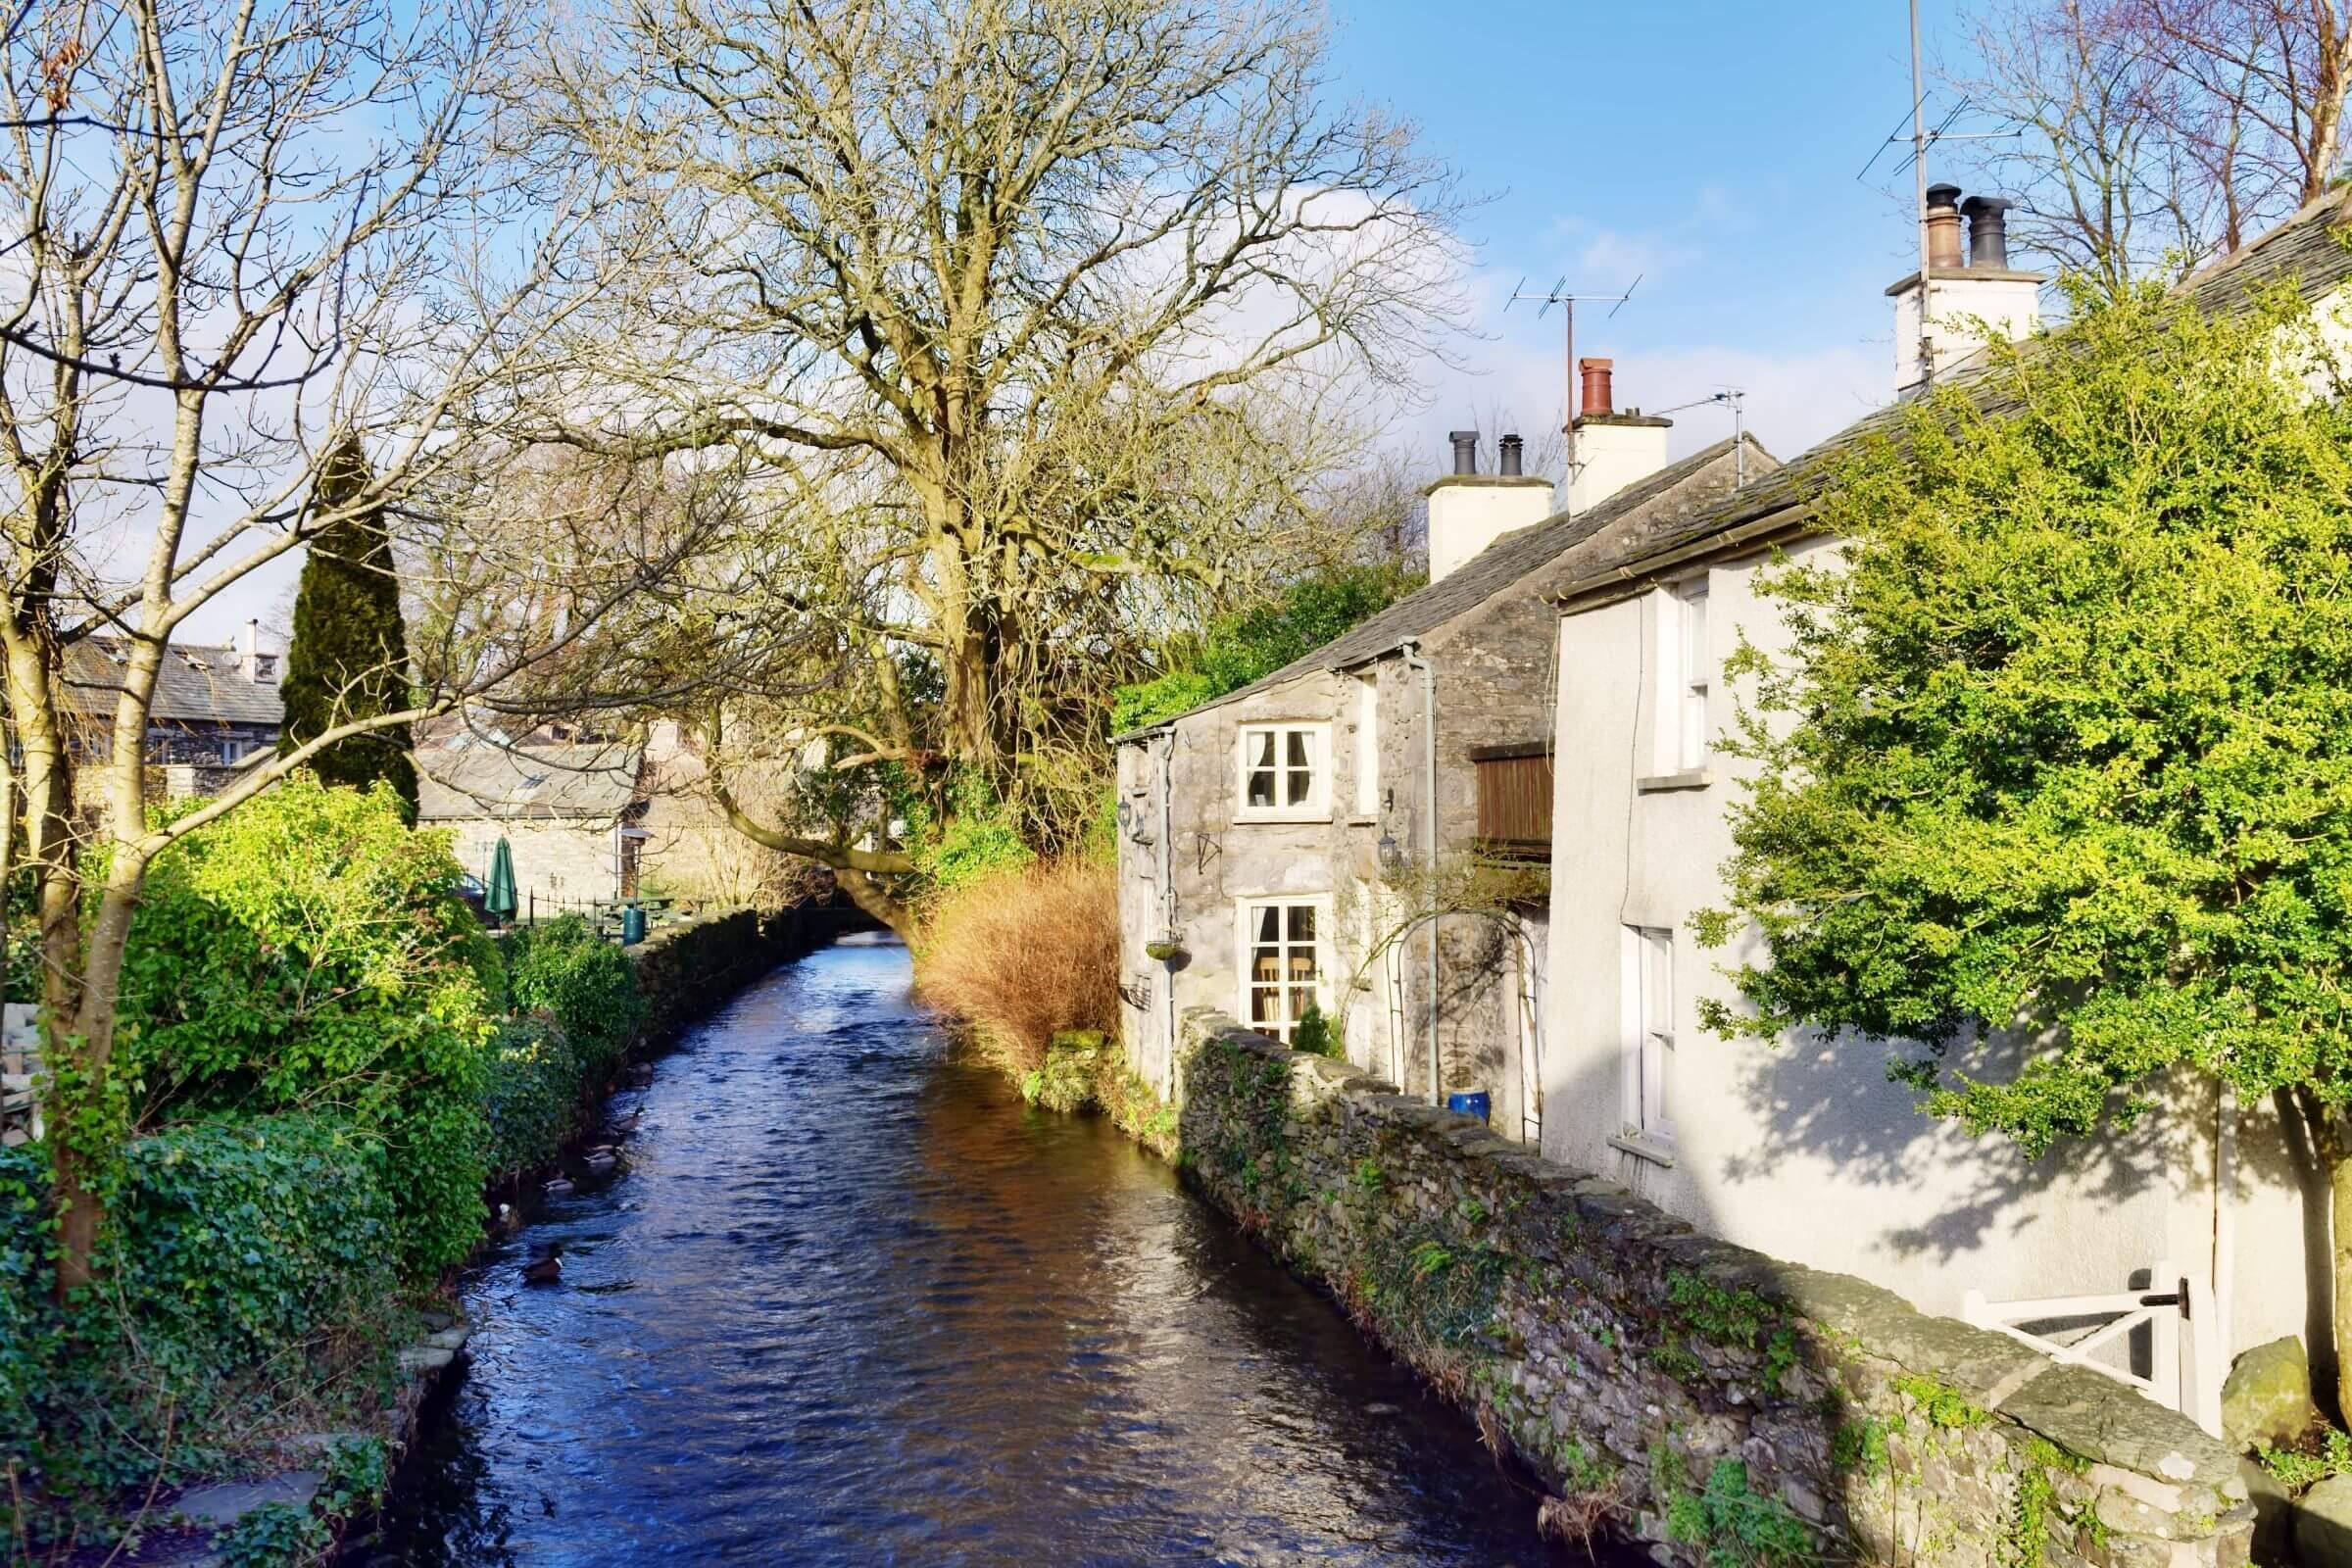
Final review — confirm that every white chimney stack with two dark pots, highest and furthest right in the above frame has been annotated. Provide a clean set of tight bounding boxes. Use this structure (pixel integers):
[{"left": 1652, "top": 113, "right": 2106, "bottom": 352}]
[{"left": 1886, "top": 186, "right": 2048, "bottom": 397}]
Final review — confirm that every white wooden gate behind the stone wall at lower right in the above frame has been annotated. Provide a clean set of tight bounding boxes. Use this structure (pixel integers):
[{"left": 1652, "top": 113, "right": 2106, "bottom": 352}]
[{"left": 1959, "top": 1262, "right": 2228, "bottom": 1437}]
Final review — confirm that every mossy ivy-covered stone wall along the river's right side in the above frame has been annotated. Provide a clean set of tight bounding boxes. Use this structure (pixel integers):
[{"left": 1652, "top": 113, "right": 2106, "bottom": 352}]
[{"left": 1178, "top": 1013, "right": 2253, "bottom": 1568}]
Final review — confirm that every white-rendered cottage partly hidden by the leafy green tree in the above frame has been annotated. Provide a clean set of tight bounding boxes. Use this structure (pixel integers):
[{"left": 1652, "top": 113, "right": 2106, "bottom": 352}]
[{"left": 1543, "top": 186, "right": 2352, "bottom": 1420}]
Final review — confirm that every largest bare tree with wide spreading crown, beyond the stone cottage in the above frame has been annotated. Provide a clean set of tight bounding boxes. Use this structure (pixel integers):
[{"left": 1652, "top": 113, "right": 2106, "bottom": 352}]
[{"left": 543, "top": 0, "right": 1456, "bottom": 930}]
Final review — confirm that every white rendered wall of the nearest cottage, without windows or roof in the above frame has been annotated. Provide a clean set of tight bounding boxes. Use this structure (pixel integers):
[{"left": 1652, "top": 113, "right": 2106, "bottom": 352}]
[{"left": 1543, "top": 543, "right": 2295, "bottom": 1349}]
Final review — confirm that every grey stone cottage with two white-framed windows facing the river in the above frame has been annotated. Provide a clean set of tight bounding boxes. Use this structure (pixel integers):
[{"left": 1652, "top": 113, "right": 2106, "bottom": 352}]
[{"left": 1117, "top": 375, "right": 1774, "bottom": 1140}]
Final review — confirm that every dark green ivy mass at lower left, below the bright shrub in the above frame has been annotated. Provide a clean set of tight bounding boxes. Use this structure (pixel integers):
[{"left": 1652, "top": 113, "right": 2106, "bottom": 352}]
[{"left": 0, "top": 1114, "right": 402, "bottom": 1543}]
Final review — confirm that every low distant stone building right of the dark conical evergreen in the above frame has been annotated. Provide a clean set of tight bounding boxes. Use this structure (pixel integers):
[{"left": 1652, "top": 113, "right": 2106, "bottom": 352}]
[{"left": 416, "top": 733, "right": 645, "bottom": 917}]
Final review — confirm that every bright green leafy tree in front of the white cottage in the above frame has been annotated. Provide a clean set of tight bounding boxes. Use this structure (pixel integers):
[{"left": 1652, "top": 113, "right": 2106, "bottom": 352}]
[{"left": 1695, "top": 278, "right": 2352, "bottom": 1403}]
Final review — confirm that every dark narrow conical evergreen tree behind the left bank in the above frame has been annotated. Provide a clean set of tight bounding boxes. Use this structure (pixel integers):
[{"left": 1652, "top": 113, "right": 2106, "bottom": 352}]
[{"left": 277, "top": 442, "right": 416, "bottom": 823}]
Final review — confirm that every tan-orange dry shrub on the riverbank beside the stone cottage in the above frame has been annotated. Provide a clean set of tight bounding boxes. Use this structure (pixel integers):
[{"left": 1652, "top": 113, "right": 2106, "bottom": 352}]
[{"left": 915, "top": 860, "right": 1119, "bottom": 1077}]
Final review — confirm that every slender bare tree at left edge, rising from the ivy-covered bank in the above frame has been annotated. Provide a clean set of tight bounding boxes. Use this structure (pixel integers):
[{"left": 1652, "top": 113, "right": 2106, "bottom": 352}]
[{"left": 0, "top": 0, "right": 701, "bottom": 1291}]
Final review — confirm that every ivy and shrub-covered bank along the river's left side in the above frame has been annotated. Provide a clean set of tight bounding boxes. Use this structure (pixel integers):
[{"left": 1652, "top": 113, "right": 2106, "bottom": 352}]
[{"left": 0, "top": 883, "right": 837, "bottom": 1568}]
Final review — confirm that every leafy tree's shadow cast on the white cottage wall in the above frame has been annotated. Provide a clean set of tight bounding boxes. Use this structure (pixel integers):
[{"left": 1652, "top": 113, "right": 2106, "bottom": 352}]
[{"left": 1710, "top": 1032, "right": 2333, "bottom": 1382}]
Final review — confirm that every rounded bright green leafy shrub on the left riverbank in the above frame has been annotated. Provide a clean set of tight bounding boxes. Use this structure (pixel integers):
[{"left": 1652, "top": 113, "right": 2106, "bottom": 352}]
[{"left": 122, "top": 773, "right": 489, "bottom": 1274}]
